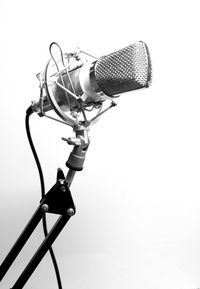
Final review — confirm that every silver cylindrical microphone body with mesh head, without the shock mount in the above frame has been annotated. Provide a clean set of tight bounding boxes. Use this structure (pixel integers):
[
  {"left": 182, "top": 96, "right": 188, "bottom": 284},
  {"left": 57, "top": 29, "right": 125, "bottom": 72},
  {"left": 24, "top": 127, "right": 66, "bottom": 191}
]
[{"left": 39, "top": 41, "right": 152, "bottom": 112}]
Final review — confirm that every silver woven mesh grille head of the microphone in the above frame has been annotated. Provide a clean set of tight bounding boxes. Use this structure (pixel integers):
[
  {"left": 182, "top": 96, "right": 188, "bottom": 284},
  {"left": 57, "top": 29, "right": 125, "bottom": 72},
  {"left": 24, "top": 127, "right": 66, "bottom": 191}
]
[{"left": 95, "top": 41, "right": 152, "bottom": 96}]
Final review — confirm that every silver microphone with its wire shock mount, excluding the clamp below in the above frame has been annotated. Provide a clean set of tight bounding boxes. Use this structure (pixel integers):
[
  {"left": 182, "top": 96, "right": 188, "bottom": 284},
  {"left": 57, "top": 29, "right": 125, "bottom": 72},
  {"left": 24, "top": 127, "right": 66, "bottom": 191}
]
[{"left": 32, "top": 41, "right": 152, "bottom": 125}]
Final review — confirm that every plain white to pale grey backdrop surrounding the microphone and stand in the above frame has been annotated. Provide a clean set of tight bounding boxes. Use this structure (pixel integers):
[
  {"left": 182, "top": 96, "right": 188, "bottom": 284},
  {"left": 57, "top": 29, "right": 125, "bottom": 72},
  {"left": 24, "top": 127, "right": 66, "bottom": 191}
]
[{"left": 0, "top": 0, "right": 200, "bottom": 289}]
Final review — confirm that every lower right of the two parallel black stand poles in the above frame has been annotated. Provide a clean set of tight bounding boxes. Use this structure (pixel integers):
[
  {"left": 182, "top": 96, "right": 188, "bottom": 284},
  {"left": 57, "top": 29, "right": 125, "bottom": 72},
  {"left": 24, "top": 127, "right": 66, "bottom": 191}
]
[{"left": 11, "top": 214, "right": 71, "bottom": 289}]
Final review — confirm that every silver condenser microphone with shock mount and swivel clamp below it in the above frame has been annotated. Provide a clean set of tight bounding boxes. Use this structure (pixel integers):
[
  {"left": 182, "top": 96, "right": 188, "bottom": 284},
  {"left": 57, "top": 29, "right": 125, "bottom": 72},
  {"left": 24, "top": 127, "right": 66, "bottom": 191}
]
[{"left": 31, "top": 41, "right": 152, "bottom": 170}]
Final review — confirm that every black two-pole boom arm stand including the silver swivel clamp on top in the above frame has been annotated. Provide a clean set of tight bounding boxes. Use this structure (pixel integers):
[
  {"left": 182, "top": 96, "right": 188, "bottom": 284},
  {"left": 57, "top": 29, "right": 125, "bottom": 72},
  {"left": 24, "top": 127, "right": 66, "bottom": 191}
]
[{"left": 0, "top": 125, "right": 89, "bottom": 289}]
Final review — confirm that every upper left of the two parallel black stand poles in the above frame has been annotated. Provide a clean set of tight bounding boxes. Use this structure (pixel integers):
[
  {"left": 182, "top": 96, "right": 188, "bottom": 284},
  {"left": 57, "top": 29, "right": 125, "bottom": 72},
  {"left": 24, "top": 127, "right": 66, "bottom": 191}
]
[{"left": 0, "top": 206, "right": 44, "bottom": 281}]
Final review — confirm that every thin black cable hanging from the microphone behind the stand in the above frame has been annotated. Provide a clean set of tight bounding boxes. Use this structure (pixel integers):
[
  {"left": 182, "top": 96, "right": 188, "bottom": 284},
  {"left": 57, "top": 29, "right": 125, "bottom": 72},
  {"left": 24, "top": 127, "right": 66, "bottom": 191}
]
[{"left": 25, "top": 106, "right": 62, "bottom": 289}]
